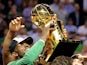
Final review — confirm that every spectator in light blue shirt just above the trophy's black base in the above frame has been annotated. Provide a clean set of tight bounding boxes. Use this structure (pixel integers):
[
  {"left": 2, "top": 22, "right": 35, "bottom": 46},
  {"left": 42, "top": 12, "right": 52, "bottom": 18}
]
[{"left": 65, "top": 19, "right": 77, "bottom": 38}]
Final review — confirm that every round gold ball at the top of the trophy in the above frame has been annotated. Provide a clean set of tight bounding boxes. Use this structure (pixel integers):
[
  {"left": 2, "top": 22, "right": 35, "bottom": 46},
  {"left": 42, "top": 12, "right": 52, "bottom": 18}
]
[{"left": 31, "top": 4, "right": 54, "bottom": 27}]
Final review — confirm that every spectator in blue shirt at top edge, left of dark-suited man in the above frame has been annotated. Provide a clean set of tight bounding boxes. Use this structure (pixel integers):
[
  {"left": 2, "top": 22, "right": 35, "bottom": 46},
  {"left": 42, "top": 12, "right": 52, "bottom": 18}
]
[{"left": 64, "top": 0, "right": 74, "bottom": 15}]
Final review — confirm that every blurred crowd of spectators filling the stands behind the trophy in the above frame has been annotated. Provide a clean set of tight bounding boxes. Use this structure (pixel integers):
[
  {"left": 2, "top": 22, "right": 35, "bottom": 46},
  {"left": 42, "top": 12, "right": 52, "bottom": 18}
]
[{"left": 0, "top": 0, "right": 87, "bottom": 65}]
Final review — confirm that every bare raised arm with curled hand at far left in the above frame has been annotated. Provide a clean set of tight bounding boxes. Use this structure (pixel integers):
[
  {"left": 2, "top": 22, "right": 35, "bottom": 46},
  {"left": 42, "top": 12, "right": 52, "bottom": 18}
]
[{"left": 2, "top": 17, "right": 22, "bottom": 65}]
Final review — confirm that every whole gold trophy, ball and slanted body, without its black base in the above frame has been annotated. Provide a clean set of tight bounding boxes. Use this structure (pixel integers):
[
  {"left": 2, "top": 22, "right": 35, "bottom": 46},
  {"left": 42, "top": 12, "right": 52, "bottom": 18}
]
[{"left": 31, "top": 4, "right": 67, "bottom": 62}]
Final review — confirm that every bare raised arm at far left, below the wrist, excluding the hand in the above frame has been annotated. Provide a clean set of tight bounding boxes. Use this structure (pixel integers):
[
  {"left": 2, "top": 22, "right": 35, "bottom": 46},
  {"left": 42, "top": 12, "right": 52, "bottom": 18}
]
[{"left": 2, "top": 30, "right": 14, "bottom": 65}]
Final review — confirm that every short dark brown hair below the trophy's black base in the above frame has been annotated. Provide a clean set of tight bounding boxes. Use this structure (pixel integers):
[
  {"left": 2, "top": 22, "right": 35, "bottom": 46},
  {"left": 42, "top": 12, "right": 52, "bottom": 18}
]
[{"left": 51, "top": 56, "right": 73, "bottom": 65}]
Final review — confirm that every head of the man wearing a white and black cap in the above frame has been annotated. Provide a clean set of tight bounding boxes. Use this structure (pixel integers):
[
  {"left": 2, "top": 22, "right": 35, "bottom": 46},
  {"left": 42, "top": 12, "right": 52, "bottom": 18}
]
[{"left": 9, "top": 36, "right": 33, "bottom": 57}]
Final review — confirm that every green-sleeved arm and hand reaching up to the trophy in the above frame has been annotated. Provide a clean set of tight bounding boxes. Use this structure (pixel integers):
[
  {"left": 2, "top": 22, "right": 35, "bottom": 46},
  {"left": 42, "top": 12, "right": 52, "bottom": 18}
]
[{"left": 8, "top": 29, "right": 48, "bottom": 65}]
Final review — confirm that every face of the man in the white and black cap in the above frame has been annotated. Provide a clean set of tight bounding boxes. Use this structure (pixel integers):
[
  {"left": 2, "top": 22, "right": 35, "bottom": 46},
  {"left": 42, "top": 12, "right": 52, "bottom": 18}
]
[{"left": 15, "top": 43, "right": 30, "bottom": 57}]
